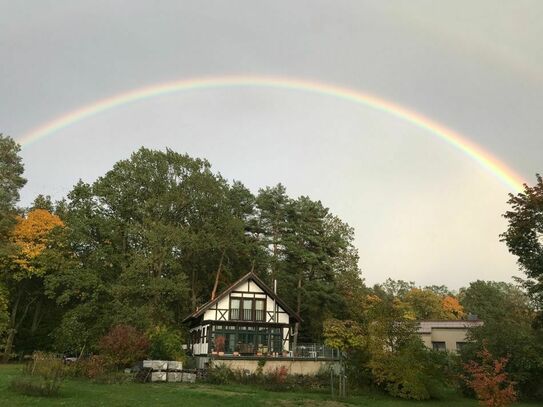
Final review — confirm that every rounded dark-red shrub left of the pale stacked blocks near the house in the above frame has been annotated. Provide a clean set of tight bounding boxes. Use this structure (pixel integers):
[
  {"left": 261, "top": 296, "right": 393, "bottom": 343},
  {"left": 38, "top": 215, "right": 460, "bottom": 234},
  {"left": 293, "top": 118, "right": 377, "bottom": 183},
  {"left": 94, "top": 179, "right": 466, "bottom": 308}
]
[{"left": 99, "top": 325, "right": 149, "bottom": 368}]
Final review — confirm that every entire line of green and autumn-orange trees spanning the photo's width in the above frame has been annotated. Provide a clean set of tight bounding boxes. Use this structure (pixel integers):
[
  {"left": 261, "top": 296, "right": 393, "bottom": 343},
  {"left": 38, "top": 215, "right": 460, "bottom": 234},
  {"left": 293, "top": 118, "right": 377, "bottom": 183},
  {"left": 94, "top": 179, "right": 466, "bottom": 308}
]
[{"left": 0, "top": 135, "right": 543, "bottom": 404}]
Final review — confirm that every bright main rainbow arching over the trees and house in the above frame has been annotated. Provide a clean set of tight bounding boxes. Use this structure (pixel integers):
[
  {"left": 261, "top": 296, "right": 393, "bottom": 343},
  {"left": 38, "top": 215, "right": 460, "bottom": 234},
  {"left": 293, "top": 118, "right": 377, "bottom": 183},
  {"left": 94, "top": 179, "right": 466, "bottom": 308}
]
[{"left": 18, "top": 76, "right": 523, "bottom": 192}]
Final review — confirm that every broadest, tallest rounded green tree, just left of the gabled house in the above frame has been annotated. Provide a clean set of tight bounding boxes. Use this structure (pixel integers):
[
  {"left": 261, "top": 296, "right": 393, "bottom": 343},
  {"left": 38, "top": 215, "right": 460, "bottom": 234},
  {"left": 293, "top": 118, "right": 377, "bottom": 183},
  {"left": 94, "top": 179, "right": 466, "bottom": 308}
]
[{"left": 47, "top": 148, "right": 258, "bottom": 348}]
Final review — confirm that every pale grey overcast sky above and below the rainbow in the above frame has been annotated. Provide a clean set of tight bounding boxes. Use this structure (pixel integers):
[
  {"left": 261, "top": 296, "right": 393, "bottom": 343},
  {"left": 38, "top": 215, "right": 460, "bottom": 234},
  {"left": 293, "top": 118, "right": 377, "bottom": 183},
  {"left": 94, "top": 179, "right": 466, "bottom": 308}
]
[{"left": 0, "top": 0, "right": 543, "bottom": 288}]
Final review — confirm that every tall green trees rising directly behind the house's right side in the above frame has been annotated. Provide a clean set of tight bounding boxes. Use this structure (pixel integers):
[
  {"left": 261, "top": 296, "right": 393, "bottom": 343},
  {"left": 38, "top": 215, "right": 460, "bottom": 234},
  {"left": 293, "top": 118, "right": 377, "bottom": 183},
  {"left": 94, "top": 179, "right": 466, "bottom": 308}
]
[{"left": 256, "top": 184, "right": 364, "bottom": 346}]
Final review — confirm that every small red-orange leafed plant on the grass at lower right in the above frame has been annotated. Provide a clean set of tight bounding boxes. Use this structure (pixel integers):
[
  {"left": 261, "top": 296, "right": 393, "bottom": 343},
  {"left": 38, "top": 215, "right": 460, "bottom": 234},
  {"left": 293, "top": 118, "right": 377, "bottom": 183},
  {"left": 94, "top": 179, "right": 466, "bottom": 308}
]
[{"left": 464, "top": 344, "right": 517, "bottom": 407}]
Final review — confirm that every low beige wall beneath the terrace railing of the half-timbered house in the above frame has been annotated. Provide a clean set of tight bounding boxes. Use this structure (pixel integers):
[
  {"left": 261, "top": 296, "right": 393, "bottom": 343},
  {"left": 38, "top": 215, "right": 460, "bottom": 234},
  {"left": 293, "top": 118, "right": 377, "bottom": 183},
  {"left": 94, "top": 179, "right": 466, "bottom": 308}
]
[{"left": 211, "top": 358, "right": 338, "bottom": 376}]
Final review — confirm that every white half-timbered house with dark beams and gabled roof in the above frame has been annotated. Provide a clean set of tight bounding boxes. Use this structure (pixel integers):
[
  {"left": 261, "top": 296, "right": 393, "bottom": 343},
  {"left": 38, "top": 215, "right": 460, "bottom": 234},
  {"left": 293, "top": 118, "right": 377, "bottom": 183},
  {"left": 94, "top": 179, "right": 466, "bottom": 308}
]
[{"left": 184, "top": 273, "right": 299, "bottom": 356}]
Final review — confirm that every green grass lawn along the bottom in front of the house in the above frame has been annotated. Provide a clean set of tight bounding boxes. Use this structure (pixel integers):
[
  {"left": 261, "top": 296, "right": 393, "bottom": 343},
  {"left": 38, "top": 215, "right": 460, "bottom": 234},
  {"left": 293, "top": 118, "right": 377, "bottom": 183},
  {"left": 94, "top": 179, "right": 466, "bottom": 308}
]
[{"left": 0, "top": 365, "right": 535, "bottom": 407}]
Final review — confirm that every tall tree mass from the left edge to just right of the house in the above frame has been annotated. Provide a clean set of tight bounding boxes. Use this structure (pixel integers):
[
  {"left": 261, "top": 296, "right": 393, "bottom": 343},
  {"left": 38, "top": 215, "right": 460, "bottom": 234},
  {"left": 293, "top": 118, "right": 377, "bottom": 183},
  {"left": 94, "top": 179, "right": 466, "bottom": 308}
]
[{"left": 0, "top": 137, "right": 361, "bottom": 357}]
